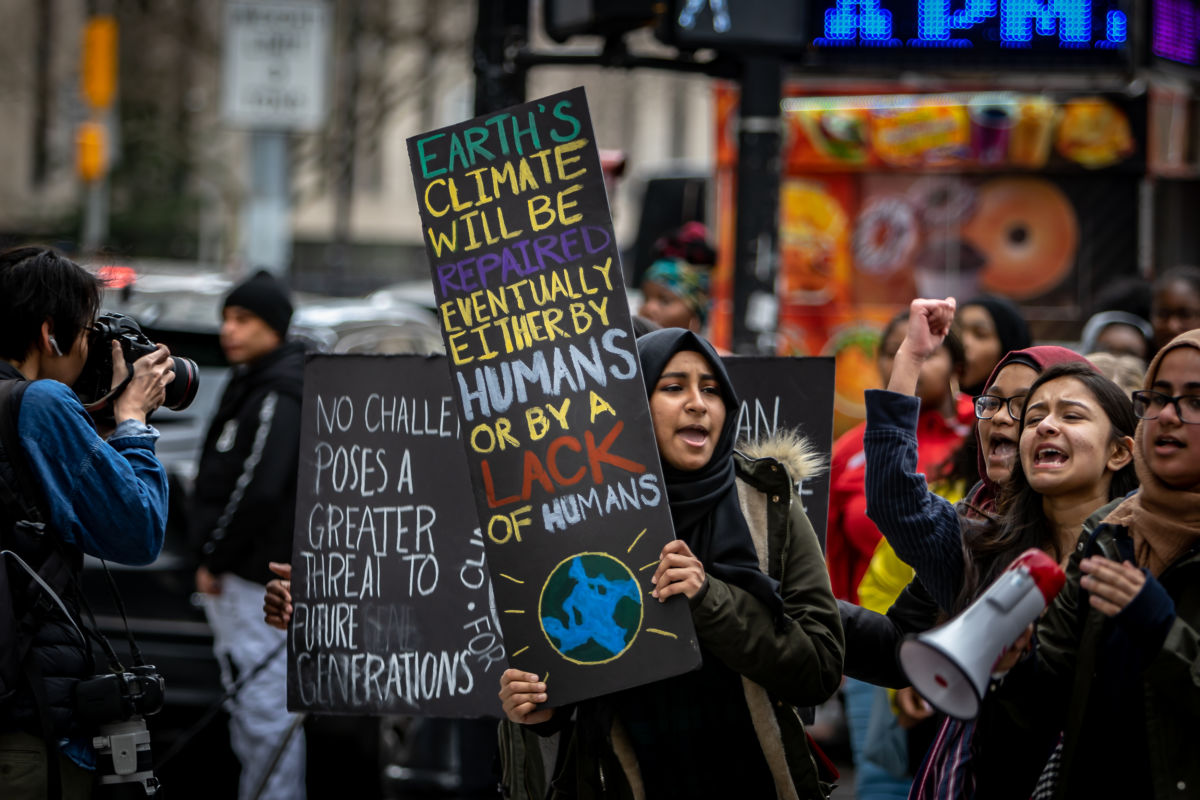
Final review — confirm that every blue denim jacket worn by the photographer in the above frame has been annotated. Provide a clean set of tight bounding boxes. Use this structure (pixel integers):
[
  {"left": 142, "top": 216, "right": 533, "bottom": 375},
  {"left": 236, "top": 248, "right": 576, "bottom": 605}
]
[{"left": 7, "top": 365, "right": 168, "bottom": 769}]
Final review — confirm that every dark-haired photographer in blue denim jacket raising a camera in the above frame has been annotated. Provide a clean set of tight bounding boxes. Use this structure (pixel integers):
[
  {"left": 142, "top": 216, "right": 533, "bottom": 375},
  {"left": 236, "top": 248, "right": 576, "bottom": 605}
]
[{"left": 0, "top": 247, "right": 174, "bottom": 799}]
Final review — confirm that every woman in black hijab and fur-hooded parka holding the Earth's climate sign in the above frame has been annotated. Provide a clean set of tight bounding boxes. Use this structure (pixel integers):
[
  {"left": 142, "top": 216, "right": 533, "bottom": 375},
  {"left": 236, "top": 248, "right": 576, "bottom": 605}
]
[{"left": 500, "top": 329, "right": 844, "bottom": 800}]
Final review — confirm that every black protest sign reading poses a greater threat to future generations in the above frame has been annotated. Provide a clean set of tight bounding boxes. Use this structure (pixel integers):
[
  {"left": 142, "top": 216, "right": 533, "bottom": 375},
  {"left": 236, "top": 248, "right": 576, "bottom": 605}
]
[{"left": 288, "top": 355, "right": 506, "bottom": 716}]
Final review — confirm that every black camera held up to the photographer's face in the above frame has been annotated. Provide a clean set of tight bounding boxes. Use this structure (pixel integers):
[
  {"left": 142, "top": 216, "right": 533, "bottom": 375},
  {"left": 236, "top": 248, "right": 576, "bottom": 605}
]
[{"left": 74, "top": 312, "right": 200, "bottom": 414}]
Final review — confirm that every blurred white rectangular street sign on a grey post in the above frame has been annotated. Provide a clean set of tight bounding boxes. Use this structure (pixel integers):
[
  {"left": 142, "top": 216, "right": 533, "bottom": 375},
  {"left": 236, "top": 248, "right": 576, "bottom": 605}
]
[{"left": 221, "top": 0, "right": 331, "bottom": 131}]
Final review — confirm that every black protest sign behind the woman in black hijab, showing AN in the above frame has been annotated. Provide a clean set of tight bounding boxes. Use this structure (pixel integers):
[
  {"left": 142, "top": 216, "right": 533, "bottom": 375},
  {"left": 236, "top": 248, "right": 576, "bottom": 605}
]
[{"left": 724, "top": 356, "right": 834, "bottom": 546}]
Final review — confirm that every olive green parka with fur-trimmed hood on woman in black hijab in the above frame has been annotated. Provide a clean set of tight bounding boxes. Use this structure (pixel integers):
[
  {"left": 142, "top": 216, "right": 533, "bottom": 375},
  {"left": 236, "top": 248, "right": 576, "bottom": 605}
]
[{"left": 500, "top": 434, "right": 845, "bottom": 800}]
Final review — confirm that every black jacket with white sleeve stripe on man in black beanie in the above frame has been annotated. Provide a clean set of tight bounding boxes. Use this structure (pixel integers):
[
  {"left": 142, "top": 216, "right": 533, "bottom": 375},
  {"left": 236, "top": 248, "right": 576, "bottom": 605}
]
[{"left": 190, "top": 342, "right": 304, "bottom": 584}]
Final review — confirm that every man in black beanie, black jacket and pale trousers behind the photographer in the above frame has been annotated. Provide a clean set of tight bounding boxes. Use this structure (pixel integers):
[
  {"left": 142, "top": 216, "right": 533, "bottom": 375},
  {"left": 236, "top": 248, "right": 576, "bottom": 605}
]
[{"left": 190, "top": 272, "right": 305, "bottom": 800}]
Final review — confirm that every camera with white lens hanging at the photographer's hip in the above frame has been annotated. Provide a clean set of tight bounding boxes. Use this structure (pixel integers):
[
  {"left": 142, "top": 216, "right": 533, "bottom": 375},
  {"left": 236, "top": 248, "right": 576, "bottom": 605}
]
[{"left": 76, "top": 666, "right": 166, "bottom": 798}]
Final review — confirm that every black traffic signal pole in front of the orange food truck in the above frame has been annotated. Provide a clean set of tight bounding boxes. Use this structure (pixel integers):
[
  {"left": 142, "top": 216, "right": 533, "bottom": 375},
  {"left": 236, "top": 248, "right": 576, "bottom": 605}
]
[{"left": 733, "top": 56, "right": 784, "bottom": 355}]
